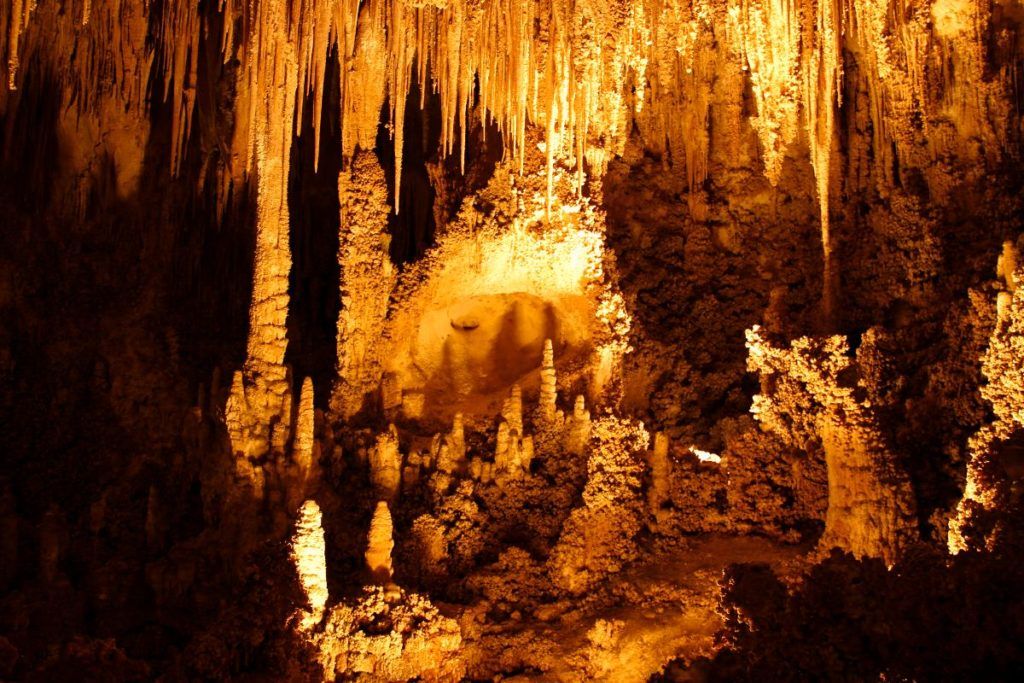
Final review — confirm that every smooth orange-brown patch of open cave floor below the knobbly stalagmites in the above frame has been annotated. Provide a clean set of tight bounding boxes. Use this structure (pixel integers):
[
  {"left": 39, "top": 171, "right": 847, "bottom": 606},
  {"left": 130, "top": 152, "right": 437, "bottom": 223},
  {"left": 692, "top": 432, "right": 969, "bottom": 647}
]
[{"left": 464, "top": 535, "right": 811, "bottom": 683}]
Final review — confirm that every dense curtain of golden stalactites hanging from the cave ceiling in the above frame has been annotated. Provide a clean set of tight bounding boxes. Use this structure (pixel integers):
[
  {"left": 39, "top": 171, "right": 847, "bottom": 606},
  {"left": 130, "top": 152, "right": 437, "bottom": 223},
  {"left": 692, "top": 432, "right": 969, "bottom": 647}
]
[{"left": 0, "top": 0, "right": 1013, "bottom": 237}]
